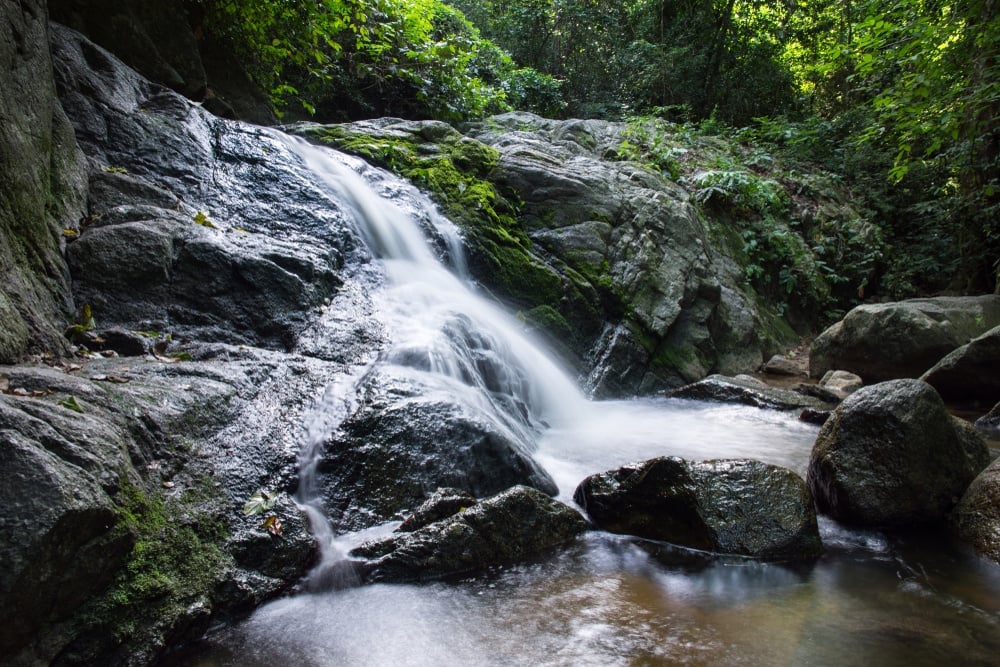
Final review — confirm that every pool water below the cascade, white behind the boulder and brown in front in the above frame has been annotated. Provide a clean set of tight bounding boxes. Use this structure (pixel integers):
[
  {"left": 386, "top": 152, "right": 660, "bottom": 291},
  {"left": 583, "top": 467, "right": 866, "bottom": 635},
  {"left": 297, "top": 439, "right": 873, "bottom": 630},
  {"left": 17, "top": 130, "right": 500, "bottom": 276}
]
[{"left": 174, "top": 401, "right": 1000, "bottom": 667}]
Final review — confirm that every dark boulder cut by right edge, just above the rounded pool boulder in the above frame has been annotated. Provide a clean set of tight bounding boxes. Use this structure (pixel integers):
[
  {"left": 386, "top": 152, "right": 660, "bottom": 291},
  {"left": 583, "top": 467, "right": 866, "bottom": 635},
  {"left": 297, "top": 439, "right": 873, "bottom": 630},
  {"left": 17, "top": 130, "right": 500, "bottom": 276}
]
[{"left": 920, "top": 326, "right": 1000, "bottom": 407}]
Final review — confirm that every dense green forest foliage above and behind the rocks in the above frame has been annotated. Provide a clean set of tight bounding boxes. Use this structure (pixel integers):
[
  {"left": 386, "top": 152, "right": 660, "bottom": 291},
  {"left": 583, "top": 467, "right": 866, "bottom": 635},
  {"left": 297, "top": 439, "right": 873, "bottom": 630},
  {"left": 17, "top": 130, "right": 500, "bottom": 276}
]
[{"left": 202, "top": 0, "right": 1000, "bottom": 312}]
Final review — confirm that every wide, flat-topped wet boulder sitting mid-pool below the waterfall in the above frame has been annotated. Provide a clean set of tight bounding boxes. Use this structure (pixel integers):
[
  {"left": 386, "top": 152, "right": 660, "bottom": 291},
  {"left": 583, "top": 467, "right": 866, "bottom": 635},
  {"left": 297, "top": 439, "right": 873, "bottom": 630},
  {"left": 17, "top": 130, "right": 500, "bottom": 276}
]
[{"left": 573, "top": 457, "right": 822, "bottom": 560}]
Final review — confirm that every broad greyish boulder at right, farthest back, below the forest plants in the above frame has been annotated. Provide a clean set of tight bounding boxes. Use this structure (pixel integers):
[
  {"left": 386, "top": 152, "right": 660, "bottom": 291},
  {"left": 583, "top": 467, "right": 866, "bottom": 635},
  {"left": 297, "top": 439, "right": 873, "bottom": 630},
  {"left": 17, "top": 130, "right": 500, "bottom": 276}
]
[{"left": 809, "top": 295, "right": 1000, "bottom": 384}]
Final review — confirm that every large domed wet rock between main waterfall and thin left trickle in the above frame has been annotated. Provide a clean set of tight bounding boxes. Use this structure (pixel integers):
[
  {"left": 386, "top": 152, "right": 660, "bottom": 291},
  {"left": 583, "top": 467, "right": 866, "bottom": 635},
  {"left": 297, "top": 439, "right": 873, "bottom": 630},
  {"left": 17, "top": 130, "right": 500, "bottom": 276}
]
[{"left": 318, "top": 367, "right": 557, "bottom": 530}]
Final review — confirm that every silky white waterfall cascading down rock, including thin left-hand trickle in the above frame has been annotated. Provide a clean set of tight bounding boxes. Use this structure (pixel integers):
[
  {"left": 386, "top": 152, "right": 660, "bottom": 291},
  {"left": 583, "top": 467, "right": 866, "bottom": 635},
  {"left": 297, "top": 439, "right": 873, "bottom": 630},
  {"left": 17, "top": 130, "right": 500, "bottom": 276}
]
[{"left": 281, "top": 135, "right": 585, "bottom": 585}]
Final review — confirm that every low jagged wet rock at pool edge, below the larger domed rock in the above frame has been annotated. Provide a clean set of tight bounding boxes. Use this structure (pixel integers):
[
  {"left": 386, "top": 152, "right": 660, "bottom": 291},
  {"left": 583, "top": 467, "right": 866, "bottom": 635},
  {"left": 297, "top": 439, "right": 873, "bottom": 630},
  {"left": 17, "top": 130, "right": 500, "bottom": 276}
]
[{"left": 349, "top": 486, "right": 587, "bottom": 582}]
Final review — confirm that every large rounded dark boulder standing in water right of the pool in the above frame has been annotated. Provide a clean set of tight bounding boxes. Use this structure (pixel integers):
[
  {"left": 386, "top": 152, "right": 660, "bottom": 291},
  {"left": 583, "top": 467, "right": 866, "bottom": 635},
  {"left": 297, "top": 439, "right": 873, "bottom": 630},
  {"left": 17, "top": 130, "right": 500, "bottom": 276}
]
[{"left": 807, "top": 380, "right": 989, "bottom": 526}]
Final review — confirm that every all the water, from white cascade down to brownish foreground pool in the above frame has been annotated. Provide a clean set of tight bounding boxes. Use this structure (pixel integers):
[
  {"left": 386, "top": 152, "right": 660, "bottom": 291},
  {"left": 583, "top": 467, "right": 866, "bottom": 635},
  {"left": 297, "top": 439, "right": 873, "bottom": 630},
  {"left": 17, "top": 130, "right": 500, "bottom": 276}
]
[{"left": 177, "top": 137, "right": 1000, "bottom": 667}]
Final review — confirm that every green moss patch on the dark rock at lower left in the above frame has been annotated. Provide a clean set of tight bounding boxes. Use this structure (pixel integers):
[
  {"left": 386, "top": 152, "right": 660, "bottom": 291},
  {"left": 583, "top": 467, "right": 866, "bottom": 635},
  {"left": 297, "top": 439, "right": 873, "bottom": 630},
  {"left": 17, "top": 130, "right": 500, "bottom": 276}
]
[{"left": 82, "top": 484, "right": 229, "bottom": 644}]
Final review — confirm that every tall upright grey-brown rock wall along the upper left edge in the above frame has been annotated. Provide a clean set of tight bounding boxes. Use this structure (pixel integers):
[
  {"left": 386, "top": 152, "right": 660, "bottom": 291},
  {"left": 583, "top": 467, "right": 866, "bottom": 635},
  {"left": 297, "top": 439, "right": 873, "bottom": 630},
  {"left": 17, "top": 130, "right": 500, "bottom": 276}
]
[{"left": 0, "top": 0, "right": 86, "bottom": 363}]
